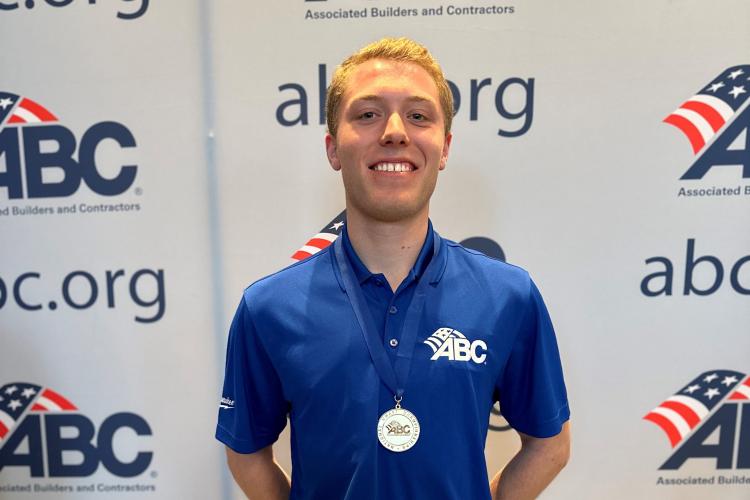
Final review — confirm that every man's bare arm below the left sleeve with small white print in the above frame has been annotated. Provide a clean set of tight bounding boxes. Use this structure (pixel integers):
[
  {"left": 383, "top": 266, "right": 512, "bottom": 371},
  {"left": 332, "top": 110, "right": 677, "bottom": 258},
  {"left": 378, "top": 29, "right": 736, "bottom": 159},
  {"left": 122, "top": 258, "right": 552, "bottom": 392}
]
[{"left": 227, "top": 446, "right": 290, "bottom": 500}]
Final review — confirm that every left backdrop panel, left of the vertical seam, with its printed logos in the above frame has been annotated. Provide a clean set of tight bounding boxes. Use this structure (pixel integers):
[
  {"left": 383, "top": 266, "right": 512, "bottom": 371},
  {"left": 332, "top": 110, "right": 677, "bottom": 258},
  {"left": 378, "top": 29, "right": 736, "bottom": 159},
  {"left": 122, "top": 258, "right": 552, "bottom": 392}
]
[{"left": 0, "top": 0, "right": 223, "bottom": 499}]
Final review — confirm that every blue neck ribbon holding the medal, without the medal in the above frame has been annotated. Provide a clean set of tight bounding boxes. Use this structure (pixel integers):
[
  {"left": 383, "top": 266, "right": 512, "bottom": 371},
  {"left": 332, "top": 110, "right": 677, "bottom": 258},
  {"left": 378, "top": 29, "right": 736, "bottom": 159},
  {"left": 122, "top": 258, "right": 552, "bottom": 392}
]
[{"left": 333, "top": 231, "right": 440, "bottom": 401}]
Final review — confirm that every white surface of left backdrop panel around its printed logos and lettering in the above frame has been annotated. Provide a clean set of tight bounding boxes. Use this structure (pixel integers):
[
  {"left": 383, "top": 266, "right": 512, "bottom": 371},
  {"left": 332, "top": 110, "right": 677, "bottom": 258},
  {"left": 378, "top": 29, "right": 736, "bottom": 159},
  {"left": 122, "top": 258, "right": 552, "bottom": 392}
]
[{"left": 0, "top": 1, "right": 223, "bottom": 499}]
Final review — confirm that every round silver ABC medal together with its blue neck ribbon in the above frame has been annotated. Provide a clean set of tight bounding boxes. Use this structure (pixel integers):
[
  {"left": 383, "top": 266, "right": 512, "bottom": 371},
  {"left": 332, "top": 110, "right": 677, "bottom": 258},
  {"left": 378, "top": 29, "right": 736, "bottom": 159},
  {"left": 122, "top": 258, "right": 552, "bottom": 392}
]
[{"left": 333, "top": 227, "right": 441, "bottom": 452}]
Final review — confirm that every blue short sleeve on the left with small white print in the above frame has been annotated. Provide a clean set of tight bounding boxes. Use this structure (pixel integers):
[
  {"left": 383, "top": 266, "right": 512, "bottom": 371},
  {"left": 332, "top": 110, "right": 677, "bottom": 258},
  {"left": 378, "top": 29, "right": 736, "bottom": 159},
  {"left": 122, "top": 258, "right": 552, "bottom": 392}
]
[{"left": 216, "top": 297, "right": 288, "bottom": 453}]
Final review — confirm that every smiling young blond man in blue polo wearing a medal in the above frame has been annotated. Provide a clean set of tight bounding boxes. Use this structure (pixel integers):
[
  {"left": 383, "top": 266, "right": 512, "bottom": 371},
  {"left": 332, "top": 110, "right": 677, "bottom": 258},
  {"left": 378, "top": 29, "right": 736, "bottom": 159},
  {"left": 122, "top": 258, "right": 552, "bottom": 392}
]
[{"left": 216, "top": 39, "right": 570, "bottom": 500}]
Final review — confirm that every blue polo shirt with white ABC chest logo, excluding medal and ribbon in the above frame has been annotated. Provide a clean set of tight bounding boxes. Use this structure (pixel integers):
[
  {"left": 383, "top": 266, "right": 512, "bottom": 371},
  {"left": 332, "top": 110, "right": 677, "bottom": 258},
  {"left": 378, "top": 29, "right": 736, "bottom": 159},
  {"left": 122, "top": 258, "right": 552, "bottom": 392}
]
[{"left": 216, "top": 226, "right": 569, "bottom": 500}]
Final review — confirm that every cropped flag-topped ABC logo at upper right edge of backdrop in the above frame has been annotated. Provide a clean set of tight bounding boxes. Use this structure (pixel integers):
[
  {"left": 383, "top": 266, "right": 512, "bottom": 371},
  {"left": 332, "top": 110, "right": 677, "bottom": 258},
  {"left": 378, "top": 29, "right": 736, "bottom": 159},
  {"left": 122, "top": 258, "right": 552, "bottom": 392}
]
[{"left": 664, "top": 65, "right": 750, "bottom": 199}]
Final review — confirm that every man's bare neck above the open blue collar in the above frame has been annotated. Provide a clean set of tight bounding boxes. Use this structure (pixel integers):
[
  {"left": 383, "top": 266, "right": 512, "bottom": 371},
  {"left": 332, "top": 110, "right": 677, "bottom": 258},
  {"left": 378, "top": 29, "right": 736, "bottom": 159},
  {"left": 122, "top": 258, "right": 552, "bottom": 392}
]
[{"left": 346, "top": 210, "right": 428, "bottom": 292}]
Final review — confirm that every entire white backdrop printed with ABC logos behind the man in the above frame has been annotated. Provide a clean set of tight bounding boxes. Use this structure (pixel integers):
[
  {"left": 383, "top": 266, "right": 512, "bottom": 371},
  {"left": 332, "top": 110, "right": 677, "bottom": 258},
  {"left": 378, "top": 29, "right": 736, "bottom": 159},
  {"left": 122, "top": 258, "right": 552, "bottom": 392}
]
[{"left": 0, "top": 0, "right": 750, "bottom": 500}]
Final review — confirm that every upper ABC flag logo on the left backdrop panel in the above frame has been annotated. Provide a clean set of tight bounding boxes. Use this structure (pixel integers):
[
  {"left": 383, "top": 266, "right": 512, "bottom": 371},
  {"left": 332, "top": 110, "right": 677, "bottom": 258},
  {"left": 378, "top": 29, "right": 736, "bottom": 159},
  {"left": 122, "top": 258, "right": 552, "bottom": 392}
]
[{"left": 0, "top": 91, "right": 142, "bottom": 217}]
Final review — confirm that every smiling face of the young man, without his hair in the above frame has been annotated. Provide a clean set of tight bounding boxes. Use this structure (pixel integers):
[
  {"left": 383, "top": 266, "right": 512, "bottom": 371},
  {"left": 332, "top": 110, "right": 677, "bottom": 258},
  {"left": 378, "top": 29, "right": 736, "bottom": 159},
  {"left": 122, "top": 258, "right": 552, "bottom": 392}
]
[{"left": 326, "top": 59, "right": 451, "bottom": 222}]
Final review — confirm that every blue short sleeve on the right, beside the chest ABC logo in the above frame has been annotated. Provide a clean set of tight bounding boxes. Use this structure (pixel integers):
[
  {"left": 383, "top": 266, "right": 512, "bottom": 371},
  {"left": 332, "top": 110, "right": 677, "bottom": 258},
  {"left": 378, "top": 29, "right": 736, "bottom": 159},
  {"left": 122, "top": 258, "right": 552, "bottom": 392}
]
[{"left": 495, "top": 281, "right": 570, "bottom": 437}]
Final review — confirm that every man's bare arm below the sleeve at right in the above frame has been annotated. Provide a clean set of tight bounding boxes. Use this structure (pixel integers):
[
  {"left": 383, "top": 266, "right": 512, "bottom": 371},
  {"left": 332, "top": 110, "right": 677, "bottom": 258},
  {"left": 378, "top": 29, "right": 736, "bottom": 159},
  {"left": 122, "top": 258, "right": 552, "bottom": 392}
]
[{"left": 490, "top": 422, "right": 570, "bottom": 500}]
